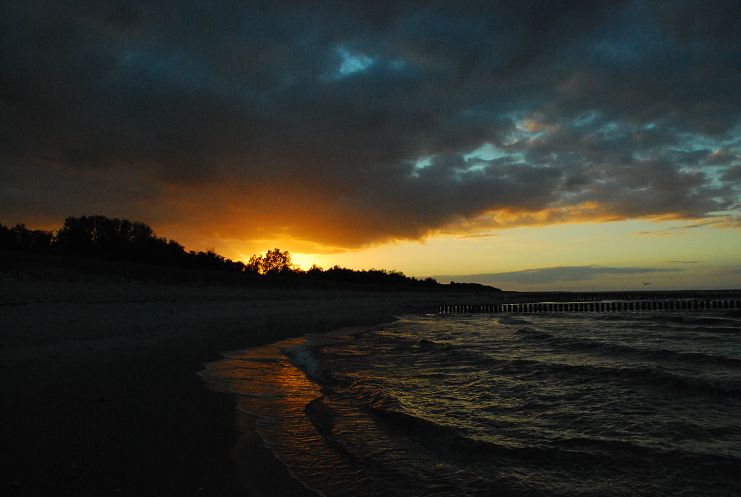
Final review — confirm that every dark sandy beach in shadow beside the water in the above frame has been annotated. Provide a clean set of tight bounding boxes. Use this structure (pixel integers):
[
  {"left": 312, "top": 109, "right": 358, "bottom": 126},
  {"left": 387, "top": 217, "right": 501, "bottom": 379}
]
[{"left": 0, "top": 273, "right": 491, "bottom": 496}]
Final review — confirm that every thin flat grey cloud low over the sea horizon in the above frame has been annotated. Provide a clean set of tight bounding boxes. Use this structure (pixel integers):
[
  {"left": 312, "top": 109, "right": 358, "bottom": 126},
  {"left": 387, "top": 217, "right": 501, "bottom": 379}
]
[{"left": 436, "top": 266, "right": 679, "bottom": 284}]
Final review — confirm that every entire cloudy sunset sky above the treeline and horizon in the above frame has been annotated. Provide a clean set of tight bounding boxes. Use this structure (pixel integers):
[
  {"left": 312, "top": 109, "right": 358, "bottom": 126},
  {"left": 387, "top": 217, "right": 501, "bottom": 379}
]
[{"left": 0, "top": 0, "right": 741, "bottom": 290}]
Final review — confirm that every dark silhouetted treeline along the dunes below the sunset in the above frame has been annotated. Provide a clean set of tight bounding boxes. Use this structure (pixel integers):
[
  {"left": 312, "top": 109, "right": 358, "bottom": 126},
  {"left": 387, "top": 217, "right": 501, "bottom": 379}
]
[{"left": 0, "top": 216, "right": 498, "bottom": 291}]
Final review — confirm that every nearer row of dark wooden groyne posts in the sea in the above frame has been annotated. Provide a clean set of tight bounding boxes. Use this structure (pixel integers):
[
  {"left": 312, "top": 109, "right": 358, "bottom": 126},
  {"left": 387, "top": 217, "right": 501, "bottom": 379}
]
[{"left": 438, "top": 299, "right": 741, "bottom": 314}]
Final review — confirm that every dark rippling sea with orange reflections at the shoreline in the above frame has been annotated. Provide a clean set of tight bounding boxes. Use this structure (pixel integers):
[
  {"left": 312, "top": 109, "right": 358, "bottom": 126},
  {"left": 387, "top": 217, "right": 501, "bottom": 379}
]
[{"left": 202, "top": 310, "right": 741, "bottom": 497}]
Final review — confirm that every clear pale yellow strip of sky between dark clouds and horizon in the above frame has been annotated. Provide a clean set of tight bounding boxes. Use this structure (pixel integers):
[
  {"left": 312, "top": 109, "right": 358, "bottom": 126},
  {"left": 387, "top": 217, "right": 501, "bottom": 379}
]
[{"left": 199, "top": 220, "right": 741, "bottom": 290}]
